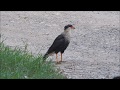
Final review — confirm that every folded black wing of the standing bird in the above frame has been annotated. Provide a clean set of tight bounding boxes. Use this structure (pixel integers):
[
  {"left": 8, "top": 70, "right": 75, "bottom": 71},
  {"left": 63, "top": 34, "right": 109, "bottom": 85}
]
[{"left": 47, "top": 34, "right": 65, "bottom": 54}]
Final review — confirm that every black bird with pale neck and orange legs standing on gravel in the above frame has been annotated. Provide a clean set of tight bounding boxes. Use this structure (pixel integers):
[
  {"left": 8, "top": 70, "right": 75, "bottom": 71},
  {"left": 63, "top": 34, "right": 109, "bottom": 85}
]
[{"left": 43, "top": 24, "right": 75, "bottom": 64}]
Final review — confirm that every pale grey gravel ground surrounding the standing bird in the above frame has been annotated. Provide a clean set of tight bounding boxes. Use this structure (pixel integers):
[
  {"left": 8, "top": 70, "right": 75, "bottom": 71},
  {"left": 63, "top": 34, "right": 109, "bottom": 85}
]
[{"left": 0, "top": 11, "right": 120, "bottom": 79}]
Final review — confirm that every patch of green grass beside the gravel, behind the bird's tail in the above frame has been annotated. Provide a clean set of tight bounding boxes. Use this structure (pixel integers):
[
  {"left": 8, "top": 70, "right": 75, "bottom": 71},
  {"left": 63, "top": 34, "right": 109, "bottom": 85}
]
[{"left": 0, "top": 42, "right": 66, "bottom": 79}]
